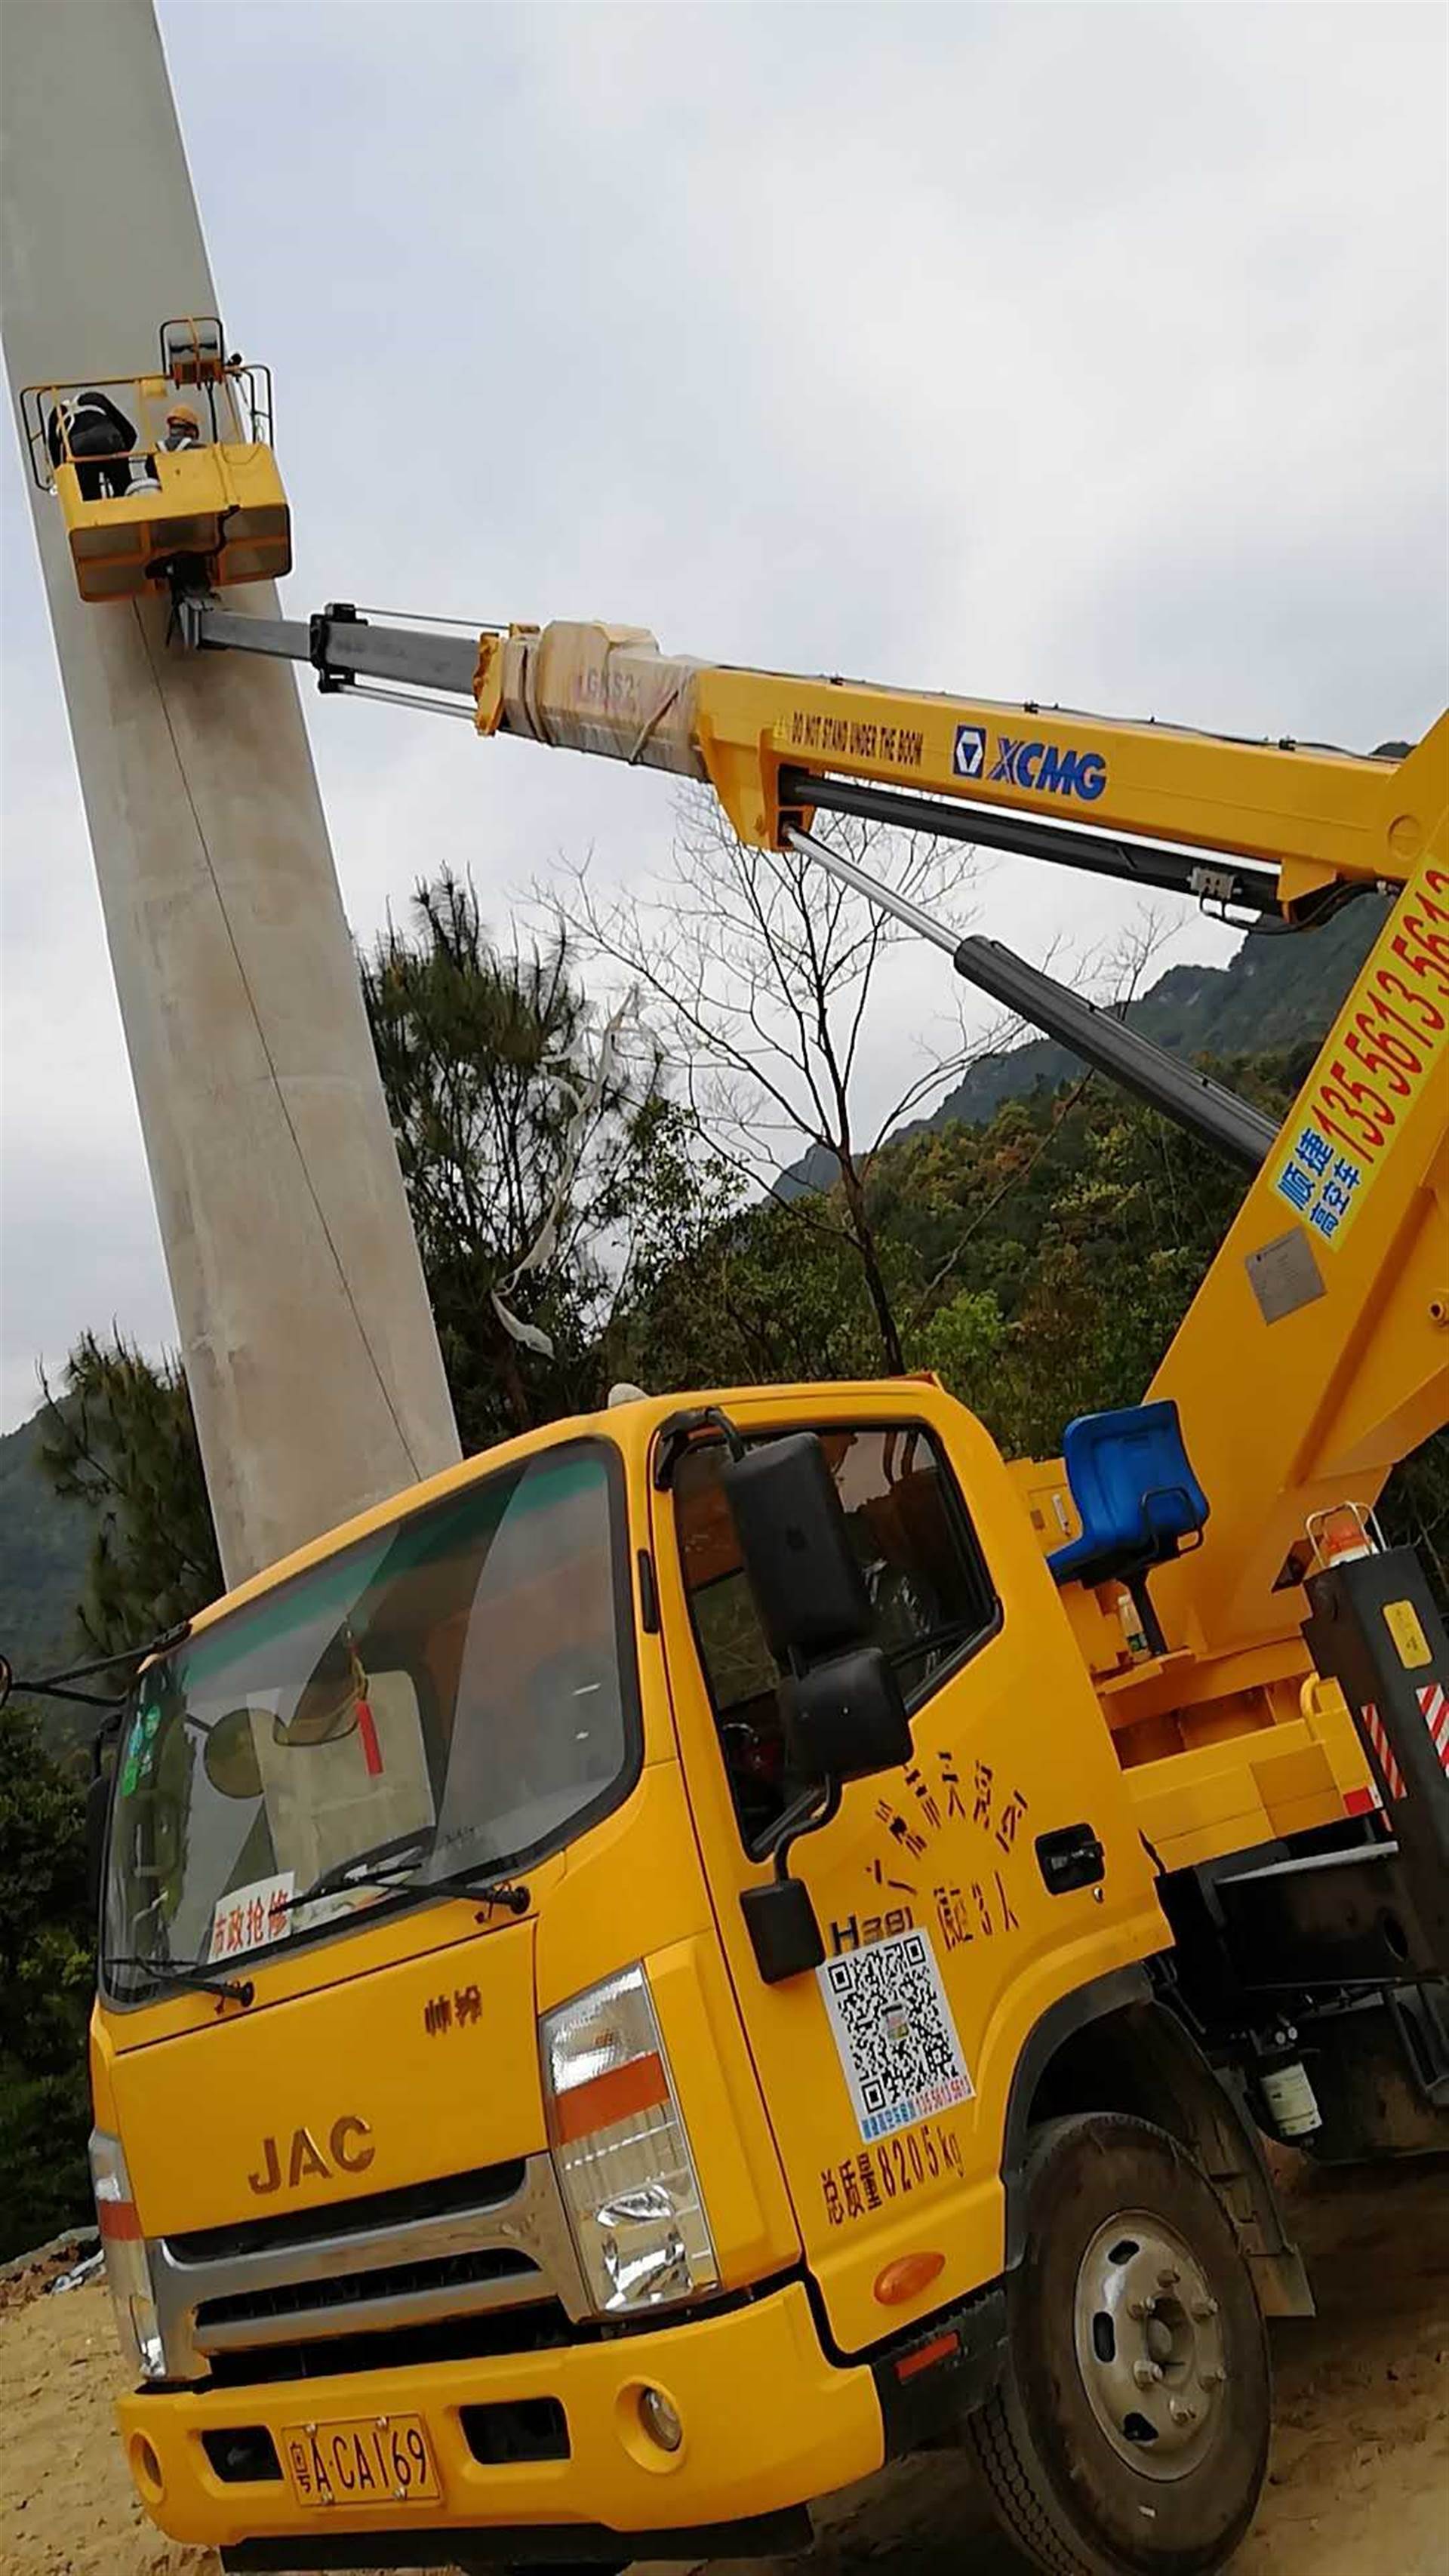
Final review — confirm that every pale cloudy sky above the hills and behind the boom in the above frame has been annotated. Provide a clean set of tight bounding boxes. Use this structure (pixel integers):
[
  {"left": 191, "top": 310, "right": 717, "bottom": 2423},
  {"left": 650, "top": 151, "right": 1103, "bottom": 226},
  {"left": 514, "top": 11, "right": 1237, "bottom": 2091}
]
[{"left": 0, "top": 0, "right": 1447, "bottom": 1427}]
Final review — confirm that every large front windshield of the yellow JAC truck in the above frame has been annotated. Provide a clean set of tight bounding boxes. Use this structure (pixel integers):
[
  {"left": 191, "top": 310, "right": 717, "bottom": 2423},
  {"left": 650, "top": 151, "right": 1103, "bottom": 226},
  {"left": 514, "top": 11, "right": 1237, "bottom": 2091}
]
[{"left": 103, "top": 1442, "right": 638, "bottom": 1999}]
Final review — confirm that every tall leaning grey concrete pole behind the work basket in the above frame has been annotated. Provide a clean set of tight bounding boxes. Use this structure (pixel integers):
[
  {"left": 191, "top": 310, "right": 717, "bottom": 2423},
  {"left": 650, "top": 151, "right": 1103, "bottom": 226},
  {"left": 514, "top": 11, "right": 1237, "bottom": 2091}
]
[{"left": 0, "top": 0, "right": 458, "bottom": 1584}]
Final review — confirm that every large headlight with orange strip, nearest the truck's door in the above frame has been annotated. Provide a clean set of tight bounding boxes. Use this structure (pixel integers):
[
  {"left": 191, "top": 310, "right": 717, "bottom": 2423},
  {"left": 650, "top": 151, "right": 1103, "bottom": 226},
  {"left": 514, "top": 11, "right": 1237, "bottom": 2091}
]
[{"left": 540, "top": 1968, "right": 721, "bottom": 2316}]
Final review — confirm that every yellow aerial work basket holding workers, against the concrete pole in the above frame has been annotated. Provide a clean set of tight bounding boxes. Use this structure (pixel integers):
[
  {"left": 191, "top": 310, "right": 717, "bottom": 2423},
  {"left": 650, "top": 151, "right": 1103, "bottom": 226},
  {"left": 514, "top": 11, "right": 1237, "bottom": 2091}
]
[{"left": 20, "top": 314, "right": 291, "bottom": 600}]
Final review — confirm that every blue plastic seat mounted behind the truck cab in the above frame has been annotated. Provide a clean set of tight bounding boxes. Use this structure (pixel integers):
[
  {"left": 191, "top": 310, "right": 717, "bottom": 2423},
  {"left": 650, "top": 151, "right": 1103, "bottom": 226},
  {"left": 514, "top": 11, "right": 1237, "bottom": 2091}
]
[{"left": 1048, "top": 1399, "right": 1207, "bottom": 1654}]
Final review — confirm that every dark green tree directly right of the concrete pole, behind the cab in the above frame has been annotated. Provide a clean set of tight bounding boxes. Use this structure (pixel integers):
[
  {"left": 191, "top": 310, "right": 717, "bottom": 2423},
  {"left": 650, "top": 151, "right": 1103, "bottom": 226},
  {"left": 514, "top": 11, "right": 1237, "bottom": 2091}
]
[{"left": 360, "top": 873, "right": 688, "bottom": 1451}]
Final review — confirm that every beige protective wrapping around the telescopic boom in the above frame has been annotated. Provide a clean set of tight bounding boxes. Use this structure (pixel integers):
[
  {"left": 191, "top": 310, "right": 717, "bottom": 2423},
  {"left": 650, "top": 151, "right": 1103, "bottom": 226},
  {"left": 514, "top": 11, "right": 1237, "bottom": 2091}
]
[{"left": 476, "top": 621, "right": 705, "bottom": 778}]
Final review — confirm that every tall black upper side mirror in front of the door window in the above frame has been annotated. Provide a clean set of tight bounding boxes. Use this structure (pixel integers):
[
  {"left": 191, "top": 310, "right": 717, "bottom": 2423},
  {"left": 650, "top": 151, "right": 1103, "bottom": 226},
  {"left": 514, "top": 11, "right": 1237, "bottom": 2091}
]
[{"left": 721, "top": 1433, "right": 870, "bottom": 1664}]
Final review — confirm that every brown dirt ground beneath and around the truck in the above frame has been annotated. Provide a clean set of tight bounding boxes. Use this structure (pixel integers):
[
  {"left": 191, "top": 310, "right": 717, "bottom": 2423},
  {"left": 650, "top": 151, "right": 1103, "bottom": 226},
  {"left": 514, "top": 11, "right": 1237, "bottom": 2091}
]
[{"left": 0, "top": 2162, "right": 1449, "bottom": 2576}]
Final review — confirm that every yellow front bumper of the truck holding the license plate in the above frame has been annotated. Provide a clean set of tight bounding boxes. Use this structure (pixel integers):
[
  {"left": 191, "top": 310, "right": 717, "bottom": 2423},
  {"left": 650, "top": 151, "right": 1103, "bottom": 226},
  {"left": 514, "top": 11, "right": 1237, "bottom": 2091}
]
[{"left": 115, "top": 2282, "right": 885, "bottom": 2568}]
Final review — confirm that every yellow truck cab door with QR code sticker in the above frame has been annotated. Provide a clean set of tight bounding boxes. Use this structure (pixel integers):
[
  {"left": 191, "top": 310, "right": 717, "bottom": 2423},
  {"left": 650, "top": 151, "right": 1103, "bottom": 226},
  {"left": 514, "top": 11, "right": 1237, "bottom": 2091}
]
[{"left": 657, "top": 1383, "right": 1168, "bottom": 2352}]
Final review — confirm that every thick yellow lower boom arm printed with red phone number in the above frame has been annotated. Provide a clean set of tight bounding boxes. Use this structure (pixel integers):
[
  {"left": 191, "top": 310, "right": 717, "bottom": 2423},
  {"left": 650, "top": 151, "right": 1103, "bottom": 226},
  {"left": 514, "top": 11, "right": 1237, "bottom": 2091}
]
[{"left": 1150, "top": 850, "right": 1449, "bottom": 1648}]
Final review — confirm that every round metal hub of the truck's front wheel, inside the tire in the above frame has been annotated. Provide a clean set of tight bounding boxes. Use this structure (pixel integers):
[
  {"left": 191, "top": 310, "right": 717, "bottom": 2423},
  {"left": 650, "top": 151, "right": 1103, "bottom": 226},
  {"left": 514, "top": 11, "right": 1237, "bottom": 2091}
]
[{"left": 1073, "top": 2210, "right": 1228, "bottom": 2478}]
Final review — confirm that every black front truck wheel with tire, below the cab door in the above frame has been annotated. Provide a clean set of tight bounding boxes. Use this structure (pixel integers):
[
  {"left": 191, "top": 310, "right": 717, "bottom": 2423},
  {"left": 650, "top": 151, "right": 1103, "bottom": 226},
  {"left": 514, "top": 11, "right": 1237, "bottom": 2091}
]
[{"left": 971, "top": 2113, "right": 1272, "bottom": 2576}]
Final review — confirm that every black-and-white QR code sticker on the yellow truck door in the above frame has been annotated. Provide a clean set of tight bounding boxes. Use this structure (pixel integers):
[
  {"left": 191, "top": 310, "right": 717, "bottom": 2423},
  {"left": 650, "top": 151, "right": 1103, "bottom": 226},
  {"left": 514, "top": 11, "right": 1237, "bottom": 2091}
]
[{"left": 816, "top": 1932, "right": 976, "bottom": 2141}]
